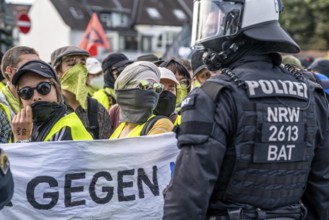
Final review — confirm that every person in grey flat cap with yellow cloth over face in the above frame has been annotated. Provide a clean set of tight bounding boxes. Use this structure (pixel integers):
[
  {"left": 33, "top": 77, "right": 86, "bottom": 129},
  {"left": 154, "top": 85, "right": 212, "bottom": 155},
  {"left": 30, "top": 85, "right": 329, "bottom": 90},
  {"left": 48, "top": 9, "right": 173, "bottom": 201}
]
[{"left": 50, "top": 46, "right": 112, "bottom": 139}]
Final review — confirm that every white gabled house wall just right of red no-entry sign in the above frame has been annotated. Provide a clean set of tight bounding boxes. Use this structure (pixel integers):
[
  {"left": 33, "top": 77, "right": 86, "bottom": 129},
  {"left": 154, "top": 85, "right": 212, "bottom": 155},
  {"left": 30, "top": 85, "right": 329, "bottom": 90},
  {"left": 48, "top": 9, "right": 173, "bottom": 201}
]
[{"left": 19, "top": 0, "right": 71, "bottom": 62}]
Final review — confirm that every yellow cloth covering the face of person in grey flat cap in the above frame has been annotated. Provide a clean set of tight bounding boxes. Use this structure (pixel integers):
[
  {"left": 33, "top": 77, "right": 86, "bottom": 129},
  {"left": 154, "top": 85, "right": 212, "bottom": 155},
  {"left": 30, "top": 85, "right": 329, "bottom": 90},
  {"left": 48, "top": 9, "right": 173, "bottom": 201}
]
[{"left": 60, "top": 63, "right": 88, "bottom": 110}]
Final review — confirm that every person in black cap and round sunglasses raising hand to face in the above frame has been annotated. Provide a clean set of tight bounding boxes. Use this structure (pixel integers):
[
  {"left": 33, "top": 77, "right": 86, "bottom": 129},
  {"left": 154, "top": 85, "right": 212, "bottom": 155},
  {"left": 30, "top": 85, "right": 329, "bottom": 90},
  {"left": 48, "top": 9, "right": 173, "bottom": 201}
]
[{"left": 12, "top": 60, "right": 92, "bottom": 143}]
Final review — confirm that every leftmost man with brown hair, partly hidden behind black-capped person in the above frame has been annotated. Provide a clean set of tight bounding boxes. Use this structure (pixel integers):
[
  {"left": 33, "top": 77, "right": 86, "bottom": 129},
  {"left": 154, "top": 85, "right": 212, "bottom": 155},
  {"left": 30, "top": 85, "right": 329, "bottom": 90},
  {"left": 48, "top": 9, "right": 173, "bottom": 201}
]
[{"left": 0, "top": 46, "right": 40, "bottom": 117}]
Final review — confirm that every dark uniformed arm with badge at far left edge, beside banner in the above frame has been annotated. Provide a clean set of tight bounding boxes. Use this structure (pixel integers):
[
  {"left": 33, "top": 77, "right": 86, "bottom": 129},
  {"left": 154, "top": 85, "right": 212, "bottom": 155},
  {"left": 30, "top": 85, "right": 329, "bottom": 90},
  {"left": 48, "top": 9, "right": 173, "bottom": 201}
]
[{"left": 0, "top": 148, "right": 14, "bottom": 210}]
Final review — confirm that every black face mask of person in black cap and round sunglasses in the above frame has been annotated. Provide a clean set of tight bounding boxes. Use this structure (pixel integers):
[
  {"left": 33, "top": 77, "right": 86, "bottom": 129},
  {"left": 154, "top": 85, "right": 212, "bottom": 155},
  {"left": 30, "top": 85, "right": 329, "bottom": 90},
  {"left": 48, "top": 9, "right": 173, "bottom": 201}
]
[{"left": 31, "top": 101, "right": 62, "bottom": 124}]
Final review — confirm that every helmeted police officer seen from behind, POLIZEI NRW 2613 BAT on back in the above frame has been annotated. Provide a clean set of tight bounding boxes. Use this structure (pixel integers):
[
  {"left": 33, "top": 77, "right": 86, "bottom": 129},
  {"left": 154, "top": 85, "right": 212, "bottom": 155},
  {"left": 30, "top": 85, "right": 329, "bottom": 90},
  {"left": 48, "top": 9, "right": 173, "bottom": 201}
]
[{"left": 164, "top": 0, "right": 329, "bottom": 220}]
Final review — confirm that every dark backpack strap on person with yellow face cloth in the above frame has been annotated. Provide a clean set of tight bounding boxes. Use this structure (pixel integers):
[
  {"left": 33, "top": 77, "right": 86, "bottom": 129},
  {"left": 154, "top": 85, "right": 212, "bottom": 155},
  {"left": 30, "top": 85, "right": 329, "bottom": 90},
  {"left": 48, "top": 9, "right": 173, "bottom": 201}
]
[{"left": 87, "top": 96, "right": 99, "bottom": 139}]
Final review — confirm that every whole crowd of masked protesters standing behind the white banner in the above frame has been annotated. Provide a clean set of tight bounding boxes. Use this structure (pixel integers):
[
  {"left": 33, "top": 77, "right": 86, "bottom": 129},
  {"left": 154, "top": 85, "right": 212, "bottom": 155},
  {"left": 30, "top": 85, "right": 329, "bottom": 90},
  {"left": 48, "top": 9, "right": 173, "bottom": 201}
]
[{"left": 0, "top": 46, "right": 329, "bottom": 143}]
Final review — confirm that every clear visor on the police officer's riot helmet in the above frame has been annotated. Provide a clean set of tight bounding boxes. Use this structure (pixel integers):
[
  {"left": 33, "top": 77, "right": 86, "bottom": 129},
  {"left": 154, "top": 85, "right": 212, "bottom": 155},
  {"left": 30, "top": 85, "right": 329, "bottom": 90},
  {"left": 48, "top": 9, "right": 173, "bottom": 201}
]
[{"left": 191, "top": 0, "right": 242, "bottom": 48}]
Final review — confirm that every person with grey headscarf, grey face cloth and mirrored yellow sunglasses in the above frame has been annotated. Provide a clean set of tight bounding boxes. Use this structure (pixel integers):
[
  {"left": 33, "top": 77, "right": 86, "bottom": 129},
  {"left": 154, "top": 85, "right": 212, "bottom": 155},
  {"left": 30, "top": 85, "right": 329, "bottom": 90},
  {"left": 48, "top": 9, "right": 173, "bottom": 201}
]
[{"left": 110, "top": 61, "right": 174, "bottom": 139}]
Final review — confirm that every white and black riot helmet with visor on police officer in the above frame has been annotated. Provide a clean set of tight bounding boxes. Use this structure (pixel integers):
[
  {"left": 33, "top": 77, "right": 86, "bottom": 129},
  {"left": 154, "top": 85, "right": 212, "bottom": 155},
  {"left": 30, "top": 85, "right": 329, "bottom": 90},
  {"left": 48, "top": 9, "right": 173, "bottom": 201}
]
[{"left": 191, "top": 0, "right": 300, "bottom": 53}]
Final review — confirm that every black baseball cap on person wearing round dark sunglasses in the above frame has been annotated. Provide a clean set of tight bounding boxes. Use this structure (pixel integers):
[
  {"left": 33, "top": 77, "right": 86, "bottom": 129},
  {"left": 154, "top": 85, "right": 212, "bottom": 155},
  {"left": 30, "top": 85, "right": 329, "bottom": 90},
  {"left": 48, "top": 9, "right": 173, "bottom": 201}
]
[{"left": 11, "top": 60, "right": 59, "bottom": 86}]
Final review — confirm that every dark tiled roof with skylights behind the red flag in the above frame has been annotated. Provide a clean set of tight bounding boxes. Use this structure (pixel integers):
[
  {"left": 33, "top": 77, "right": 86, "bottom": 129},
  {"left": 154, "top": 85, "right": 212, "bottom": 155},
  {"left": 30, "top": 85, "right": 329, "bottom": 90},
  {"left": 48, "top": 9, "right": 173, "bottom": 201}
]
[{"left": 51, "top": 0, "right": 193, "bottom": 30}]
